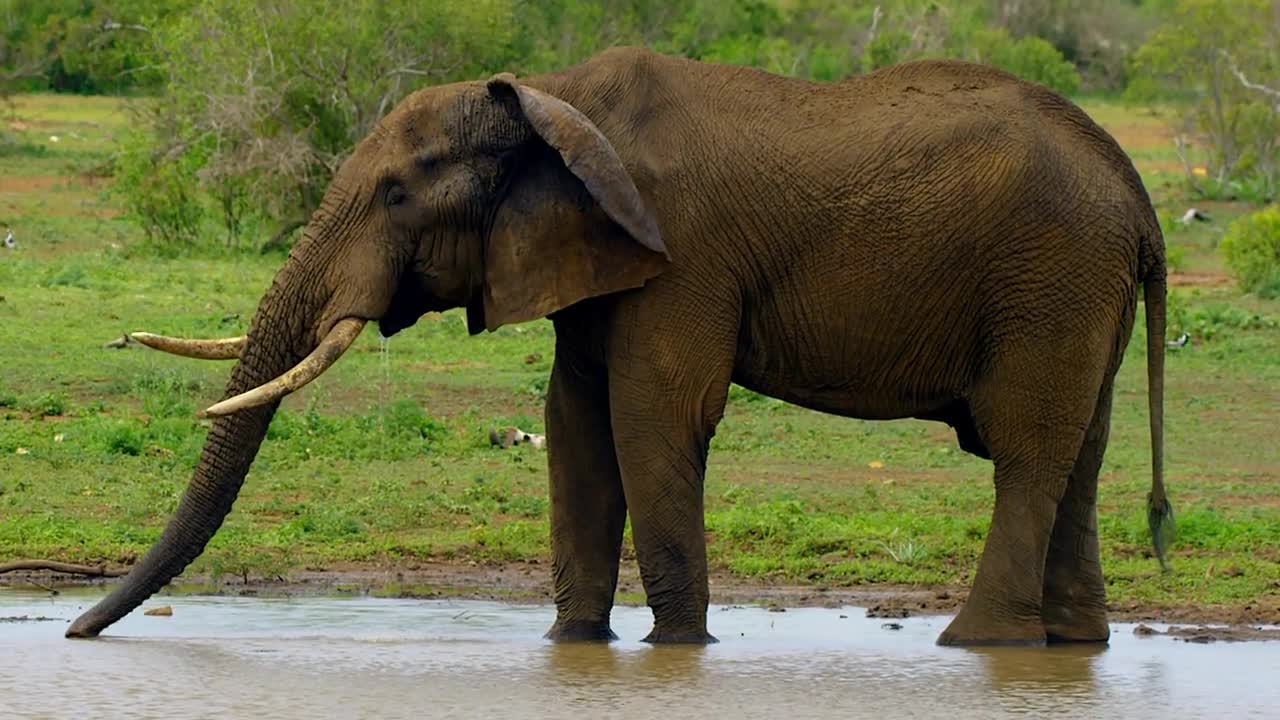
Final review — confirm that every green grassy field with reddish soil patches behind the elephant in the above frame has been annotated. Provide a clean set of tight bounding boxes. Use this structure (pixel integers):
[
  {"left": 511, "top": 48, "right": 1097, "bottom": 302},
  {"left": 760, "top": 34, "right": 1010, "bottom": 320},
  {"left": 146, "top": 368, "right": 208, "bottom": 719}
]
[{"left": 0, "top": 96, "right": 1280, "bottom": 614}]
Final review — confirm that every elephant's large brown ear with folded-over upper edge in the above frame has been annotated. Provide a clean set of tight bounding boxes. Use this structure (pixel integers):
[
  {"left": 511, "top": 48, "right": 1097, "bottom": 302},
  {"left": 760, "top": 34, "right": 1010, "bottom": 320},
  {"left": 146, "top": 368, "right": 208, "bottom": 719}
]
[{"left": 472, "top": 73, "right": 668, "bottom": 332}]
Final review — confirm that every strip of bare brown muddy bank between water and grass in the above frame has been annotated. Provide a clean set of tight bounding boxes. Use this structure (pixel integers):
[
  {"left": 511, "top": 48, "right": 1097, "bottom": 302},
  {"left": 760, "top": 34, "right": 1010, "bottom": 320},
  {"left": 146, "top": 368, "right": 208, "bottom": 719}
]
[{"left": 0, "top": 562, "right": 1280, "bottom": 630}]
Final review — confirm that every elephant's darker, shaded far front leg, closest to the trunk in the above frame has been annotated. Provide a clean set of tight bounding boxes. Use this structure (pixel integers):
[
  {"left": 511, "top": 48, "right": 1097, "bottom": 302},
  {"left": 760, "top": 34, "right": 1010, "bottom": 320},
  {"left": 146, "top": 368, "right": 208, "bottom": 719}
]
[{"left": 547, "top": 341, "right": 626, "bottom": 641}]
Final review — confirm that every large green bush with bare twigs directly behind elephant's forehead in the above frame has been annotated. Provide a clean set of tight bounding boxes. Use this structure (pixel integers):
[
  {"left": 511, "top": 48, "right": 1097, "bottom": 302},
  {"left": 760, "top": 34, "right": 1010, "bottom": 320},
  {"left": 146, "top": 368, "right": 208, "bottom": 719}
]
[{"left": 108, "top": 0, "right": 517, "bottom": 250}]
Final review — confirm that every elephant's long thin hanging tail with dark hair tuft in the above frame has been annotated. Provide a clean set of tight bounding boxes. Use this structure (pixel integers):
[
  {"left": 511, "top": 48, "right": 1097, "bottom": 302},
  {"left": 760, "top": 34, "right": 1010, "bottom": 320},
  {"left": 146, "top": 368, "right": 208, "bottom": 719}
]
[{"left": 1142, "top": 225, "right": 1176, "bottom": 570}]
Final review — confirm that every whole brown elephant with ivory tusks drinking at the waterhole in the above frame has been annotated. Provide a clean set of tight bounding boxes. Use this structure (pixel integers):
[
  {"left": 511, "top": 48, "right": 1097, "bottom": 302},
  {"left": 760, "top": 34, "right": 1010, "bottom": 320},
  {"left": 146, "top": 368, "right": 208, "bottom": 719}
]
[{"left": 67, "top": 47, "right": 1172, "bottom": 646}]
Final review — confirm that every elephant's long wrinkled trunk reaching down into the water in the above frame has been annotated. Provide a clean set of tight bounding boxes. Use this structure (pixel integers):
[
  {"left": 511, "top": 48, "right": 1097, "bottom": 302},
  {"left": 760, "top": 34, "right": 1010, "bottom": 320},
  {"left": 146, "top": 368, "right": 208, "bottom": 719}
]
[{"left": 67, "top": 258, "right": 324, "bottom": 638}]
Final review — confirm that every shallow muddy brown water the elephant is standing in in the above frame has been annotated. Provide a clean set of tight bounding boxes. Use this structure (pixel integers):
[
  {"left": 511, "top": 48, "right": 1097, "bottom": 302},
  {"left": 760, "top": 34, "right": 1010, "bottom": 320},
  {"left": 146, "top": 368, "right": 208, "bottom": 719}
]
[{"left": 0, "top": 589, "right": 1280, "bottom": 720}]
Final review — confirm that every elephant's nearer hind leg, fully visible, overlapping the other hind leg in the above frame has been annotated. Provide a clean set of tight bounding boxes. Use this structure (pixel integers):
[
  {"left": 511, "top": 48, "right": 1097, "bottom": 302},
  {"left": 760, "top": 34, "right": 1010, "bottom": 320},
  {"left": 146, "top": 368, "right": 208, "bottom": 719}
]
[{"left": 938, "top": 347, "right": 1102, "bottom": 646}]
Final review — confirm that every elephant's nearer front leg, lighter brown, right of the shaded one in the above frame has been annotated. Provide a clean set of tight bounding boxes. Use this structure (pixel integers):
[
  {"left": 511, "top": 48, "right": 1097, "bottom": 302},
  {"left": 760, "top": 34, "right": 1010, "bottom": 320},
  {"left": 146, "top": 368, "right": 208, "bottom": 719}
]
[{"left": 609, "top": 294, "right": 736, "bottom": 643}]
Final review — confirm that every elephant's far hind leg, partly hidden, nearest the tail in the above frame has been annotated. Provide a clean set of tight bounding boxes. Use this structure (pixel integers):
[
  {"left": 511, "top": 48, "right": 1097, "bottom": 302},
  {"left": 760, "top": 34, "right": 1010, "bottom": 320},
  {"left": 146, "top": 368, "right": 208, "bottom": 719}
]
[{"left": 1041, "top": 375, "right": 1114, "bottom": 642}]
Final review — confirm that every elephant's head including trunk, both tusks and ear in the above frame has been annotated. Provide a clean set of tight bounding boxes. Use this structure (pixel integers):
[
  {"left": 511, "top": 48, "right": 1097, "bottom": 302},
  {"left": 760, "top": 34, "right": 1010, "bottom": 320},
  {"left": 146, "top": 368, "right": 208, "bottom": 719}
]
[{"left": 67, "top": 74, "right": 667, "bottom": 637}]
